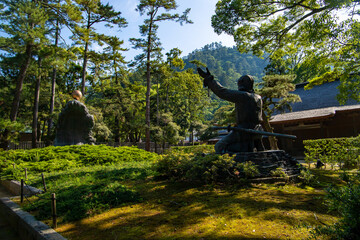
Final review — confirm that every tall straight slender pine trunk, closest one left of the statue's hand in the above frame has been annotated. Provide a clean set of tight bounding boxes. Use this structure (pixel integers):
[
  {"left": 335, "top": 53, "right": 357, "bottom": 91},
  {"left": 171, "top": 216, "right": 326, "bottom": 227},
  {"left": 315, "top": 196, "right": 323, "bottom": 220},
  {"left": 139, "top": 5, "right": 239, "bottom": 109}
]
[{"left": 145, "top": 18, "right": 153, "bottom": 151}]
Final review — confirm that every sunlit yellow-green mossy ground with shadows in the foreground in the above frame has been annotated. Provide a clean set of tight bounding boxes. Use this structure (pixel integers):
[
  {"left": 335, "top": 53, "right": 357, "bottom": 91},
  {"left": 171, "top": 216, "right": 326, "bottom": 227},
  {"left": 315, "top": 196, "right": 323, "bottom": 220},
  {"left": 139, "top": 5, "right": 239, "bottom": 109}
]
[{"left": 51, "top": 179, "right": 337, "bottom": 239}]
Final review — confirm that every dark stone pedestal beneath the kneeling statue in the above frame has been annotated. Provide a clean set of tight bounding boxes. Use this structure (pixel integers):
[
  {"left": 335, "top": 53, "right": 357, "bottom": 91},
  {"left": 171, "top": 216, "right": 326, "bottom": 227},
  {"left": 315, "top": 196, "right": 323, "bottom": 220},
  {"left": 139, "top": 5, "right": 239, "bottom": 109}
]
[{"left": 234, "top": 150, "right": 301, "bottom": 180}]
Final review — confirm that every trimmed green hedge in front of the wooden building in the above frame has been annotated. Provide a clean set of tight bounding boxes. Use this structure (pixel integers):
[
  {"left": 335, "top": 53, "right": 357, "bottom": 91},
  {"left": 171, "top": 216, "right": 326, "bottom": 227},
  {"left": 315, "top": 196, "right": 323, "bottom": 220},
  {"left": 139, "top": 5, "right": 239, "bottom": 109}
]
[{"left": 303, "top": 135, "right": 360, "bottom": 168}]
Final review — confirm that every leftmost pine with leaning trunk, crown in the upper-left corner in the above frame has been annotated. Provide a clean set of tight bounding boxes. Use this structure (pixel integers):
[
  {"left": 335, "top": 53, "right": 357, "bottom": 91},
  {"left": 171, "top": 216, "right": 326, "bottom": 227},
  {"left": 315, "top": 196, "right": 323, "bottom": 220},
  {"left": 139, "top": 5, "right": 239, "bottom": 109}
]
[{"left": 0, "top": 0, "right": 49, "bottom": 149}]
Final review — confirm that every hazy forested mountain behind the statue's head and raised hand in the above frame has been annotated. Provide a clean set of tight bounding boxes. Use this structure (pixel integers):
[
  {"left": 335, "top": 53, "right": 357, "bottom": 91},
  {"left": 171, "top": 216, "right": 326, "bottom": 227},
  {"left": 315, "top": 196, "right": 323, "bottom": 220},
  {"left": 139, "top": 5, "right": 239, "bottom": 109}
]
[{"left": 183, "top": 43, "right": 268, "bottom": 89}]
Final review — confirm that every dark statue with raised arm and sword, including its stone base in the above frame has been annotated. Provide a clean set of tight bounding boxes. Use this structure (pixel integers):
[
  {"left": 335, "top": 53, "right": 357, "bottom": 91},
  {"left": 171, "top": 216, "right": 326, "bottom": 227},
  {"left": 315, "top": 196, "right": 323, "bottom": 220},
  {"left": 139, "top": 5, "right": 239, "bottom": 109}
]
[{"left": 197, "top": 68, "right": 300, "bottom": 178}]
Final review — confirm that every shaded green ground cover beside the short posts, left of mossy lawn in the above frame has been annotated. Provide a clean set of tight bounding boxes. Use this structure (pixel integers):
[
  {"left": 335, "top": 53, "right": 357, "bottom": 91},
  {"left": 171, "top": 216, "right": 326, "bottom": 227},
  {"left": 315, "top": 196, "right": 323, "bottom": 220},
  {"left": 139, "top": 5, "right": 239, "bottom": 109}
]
[{"left": 25, "top": 164, "right": 154, "bottom": 222}]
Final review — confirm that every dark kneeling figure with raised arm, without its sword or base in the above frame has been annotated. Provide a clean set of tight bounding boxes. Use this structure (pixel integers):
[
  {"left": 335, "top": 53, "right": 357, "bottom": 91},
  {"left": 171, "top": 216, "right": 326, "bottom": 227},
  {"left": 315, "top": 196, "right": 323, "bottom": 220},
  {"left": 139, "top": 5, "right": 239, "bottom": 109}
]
[{"left": 198, "top": 68, "right": 264, "bottom": 154}]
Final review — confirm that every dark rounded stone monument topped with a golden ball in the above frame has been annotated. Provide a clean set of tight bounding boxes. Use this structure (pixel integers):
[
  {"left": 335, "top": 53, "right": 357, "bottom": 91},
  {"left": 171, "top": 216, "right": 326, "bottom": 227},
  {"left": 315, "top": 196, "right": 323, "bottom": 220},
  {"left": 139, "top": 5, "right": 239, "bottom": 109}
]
[{"left": 54, "top": 90, "right": 95, "bottom": 146}]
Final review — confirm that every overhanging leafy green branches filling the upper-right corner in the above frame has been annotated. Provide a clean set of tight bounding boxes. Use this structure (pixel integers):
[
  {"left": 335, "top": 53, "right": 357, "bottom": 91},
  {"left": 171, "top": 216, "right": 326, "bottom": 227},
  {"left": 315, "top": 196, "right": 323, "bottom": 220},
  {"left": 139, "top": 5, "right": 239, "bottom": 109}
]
[{"left": 212, "top": 0, "right": 360, "bottom": 103}]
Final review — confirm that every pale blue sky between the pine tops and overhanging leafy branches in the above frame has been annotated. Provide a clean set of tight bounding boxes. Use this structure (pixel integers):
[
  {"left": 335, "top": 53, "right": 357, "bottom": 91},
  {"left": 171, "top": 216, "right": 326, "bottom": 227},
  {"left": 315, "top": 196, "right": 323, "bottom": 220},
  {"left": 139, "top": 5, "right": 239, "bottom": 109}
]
[{"left": 101, "top": 0, "right": 235, "bottom": 61}]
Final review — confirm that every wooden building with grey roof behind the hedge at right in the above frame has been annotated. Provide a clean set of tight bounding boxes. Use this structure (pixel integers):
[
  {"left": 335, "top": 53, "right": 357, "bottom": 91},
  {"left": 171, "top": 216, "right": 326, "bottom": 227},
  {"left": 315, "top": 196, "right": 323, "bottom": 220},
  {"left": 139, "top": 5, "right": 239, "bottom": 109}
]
[{"left": 270, "top": 81, "right": 360, "bottom": 156}]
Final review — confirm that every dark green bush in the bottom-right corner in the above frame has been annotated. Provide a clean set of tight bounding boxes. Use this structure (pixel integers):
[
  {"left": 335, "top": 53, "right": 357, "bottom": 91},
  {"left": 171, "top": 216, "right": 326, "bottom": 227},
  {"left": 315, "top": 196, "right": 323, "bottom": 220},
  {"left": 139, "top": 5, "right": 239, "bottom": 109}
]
[{"left": 312, "top": 174, "right": 360, "bottom": 240}]
